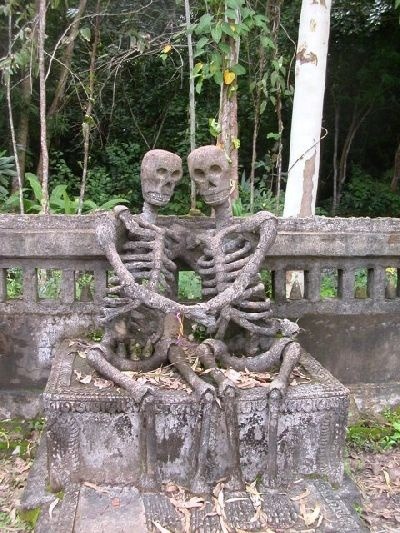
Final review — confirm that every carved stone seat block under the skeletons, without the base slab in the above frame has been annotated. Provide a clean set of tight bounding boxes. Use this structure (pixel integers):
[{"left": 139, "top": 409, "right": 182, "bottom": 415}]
[{"left": 43, "top": 342, "right": 349, "bottom": 490}]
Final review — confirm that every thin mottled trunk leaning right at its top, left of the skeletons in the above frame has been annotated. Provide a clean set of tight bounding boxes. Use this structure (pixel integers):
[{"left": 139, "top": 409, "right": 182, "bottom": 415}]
[{"left": 78, "top": 0, "right": 101, "bottom": 215}]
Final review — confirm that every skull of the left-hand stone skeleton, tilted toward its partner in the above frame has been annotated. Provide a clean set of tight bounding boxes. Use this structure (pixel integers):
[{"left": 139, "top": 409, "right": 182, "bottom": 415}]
[{"left": 140, "top": 150, "right": 182, "bottom": 207}]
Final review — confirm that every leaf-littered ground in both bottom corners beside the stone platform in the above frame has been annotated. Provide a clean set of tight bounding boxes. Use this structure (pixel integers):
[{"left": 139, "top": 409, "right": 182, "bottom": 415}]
[{"left": 0, "top": 422, "right": 400, "bottom": 533}]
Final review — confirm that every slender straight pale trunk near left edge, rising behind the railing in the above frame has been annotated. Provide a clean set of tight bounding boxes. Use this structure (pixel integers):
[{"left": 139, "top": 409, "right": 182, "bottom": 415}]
[{"left": 38, "top": 0, "right": 49, "bottom": 215}]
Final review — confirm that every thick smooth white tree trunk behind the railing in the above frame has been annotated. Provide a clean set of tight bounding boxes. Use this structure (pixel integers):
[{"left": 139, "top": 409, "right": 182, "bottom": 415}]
[{"left": 284, "top": 0, "right": 331, "bottom": 217}]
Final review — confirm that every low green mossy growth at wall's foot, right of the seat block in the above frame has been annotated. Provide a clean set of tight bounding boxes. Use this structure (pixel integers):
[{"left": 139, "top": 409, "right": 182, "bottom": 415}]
[{"left": 347, "top": 408, "right": 400, "bottom": 452}]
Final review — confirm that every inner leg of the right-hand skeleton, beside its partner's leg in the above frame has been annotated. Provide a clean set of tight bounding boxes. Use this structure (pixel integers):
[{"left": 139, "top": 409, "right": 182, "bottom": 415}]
[{"left": 196, "top": 339, "right": 244, "bottom": 491}]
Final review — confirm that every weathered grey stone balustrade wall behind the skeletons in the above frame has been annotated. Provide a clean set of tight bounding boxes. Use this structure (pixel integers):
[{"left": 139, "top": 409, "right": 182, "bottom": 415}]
[{"left": 0, "top": 214, "right": 400, "bottom": 412}]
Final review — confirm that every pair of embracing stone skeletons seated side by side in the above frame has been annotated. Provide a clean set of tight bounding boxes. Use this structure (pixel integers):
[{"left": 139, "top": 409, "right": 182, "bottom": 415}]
[{"left": 88, "top": 146, "right": 300, "bottom": 516}]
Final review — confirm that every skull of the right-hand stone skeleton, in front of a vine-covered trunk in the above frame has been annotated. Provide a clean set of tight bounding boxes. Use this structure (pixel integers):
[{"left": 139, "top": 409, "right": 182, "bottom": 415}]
[{"left": 188, "top": 145, "right": 231, "bottom": 206}]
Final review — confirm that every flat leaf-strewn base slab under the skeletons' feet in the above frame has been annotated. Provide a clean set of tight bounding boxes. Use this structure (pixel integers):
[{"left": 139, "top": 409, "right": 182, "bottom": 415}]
[{"left": 22, "top": 438, "right": 367, "bottom": 533}]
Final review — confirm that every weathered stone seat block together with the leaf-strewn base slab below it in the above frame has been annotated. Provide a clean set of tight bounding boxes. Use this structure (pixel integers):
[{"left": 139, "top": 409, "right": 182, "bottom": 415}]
[{"left": 21, "top": 341, "right": 364, "bottom": 533}]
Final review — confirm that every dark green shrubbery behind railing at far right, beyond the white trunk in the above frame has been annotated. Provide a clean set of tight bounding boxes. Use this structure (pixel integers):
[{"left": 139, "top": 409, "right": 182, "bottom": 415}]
[{"left": 339, "top": 165, "right": 400, "bottom": 217}]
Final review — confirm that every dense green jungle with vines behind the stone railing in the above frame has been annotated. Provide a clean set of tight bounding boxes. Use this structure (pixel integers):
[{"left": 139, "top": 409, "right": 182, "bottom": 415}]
[{"left": 0, "top": 0, "right": 400, "bottom": 217}]
